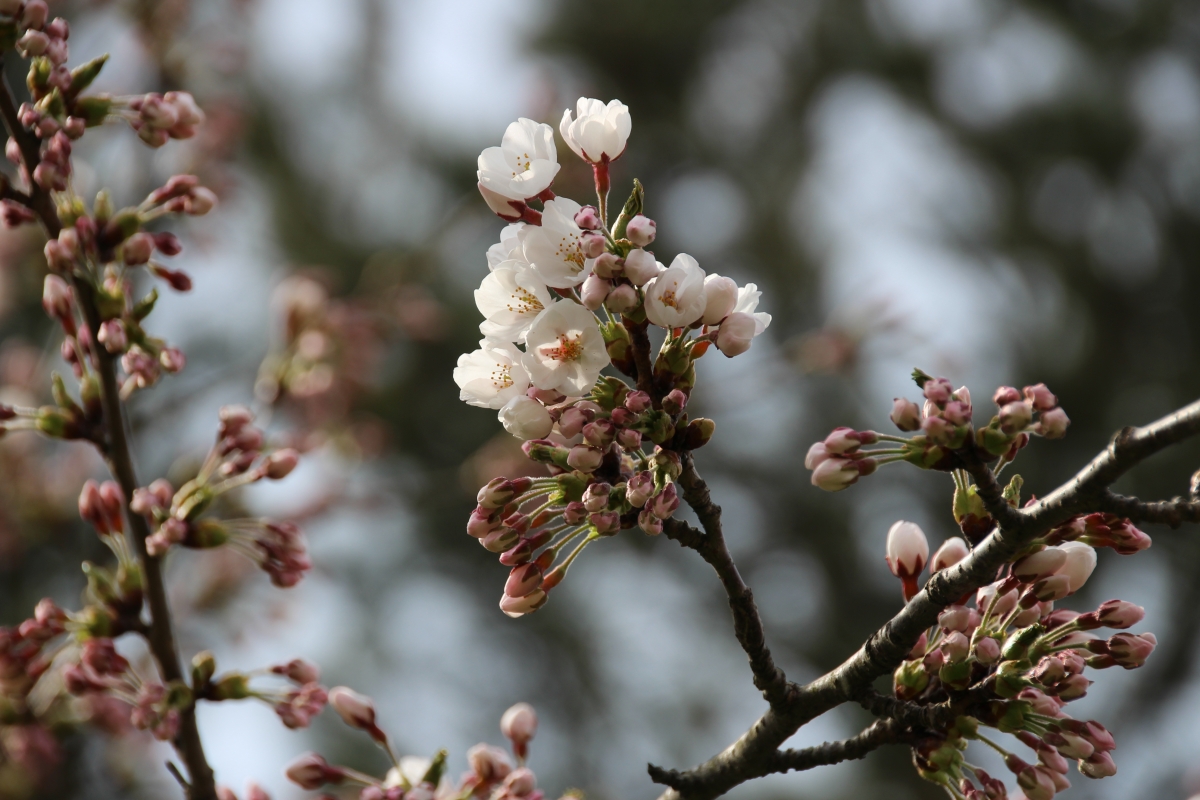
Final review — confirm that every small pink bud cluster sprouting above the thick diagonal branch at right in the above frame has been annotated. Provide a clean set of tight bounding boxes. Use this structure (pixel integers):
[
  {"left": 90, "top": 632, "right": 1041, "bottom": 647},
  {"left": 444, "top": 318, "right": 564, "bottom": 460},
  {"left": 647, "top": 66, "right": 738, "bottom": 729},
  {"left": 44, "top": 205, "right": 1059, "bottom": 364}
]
[{"left": 804, "top": 369, "right": 1070, "bottom": 492}]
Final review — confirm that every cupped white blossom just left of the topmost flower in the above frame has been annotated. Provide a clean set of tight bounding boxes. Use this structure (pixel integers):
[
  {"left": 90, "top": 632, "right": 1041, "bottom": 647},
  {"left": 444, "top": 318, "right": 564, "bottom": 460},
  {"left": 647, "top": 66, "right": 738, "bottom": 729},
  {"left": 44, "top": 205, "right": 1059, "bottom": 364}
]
[{"left": 476, "top": 116, "right": 558, "bottom": 200}]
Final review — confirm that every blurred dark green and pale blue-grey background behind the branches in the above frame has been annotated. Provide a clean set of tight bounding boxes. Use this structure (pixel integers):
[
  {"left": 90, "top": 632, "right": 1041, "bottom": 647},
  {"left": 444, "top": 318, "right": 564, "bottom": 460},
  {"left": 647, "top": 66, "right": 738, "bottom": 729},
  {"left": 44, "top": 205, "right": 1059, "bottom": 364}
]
[{"left": 0, "top": 0, "right": 1200, "bottom": 800}]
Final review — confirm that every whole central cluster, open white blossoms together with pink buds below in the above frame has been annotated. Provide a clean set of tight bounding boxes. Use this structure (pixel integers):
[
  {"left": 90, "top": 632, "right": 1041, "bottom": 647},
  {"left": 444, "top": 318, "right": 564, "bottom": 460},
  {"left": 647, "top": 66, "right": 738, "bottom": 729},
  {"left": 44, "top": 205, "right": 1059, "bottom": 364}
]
[{"left": 454, "top": 98, "right": 770, "bottom": 616}]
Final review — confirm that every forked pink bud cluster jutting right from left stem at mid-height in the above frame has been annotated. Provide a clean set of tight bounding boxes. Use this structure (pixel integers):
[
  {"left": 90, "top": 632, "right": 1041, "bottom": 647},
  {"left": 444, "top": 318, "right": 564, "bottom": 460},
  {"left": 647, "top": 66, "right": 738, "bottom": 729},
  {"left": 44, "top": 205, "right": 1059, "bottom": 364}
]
[{"left": 130, "top": 405, "right": 312, "bottom": 588}]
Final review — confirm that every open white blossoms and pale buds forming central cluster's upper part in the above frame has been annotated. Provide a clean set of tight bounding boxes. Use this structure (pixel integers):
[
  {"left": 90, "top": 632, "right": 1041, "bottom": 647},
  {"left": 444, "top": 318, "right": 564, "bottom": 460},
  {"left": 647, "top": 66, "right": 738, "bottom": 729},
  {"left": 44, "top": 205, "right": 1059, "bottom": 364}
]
[{"left": 454, "top": 97, "right": 770, "bottom": 439}]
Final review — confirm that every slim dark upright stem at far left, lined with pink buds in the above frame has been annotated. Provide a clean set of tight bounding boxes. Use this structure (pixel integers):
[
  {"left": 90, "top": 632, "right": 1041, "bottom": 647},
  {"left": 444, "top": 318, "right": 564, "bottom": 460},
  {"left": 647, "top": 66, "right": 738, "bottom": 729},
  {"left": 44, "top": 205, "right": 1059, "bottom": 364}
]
[{"left": 0, "top": 73, "right": 217, "bottom": 800}]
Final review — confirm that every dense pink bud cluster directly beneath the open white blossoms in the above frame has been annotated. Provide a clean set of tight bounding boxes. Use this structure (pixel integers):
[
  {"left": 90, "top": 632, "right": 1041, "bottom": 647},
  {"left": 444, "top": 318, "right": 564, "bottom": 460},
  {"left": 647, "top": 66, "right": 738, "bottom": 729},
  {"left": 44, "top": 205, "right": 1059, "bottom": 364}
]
[{"left": 467, "top": 378, "right": 715, "bottom": 616}]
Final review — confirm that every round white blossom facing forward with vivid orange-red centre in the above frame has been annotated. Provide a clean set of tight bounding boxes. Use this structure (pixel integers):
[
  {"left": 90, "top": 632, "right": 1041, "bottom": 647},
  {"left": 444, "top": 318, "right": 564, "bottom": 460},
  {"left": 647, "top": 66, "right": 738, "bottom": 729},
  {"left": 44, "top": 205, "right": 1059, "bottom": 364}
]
[{"left": 524, "top": 300, "right": 608, "bottom": 396}]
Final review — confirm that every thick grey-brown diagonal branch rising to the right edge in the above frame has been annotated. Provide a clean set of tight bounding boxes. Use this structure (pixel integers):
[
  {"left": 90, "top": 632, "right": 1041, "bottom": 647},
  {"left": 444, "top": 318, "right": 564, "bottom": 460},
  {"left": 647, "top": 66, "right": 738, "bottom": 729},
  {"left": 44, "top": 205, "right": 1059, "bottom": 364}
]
[{"left": 661, "top": 402, "right": 1200, "bottom": 800}]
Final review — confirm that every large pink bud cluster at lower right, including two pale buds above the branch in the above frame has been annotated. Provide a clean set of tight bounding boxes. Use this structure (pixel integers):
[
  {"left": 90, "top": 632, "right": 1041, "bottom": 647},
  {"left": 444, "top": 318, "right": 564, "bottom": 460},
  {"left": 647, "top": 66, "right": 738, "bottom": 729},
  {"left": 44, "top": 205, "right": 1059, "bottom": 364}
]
[{"left": 887, "top": 522, "right": 1157, "bottom": 800}]
